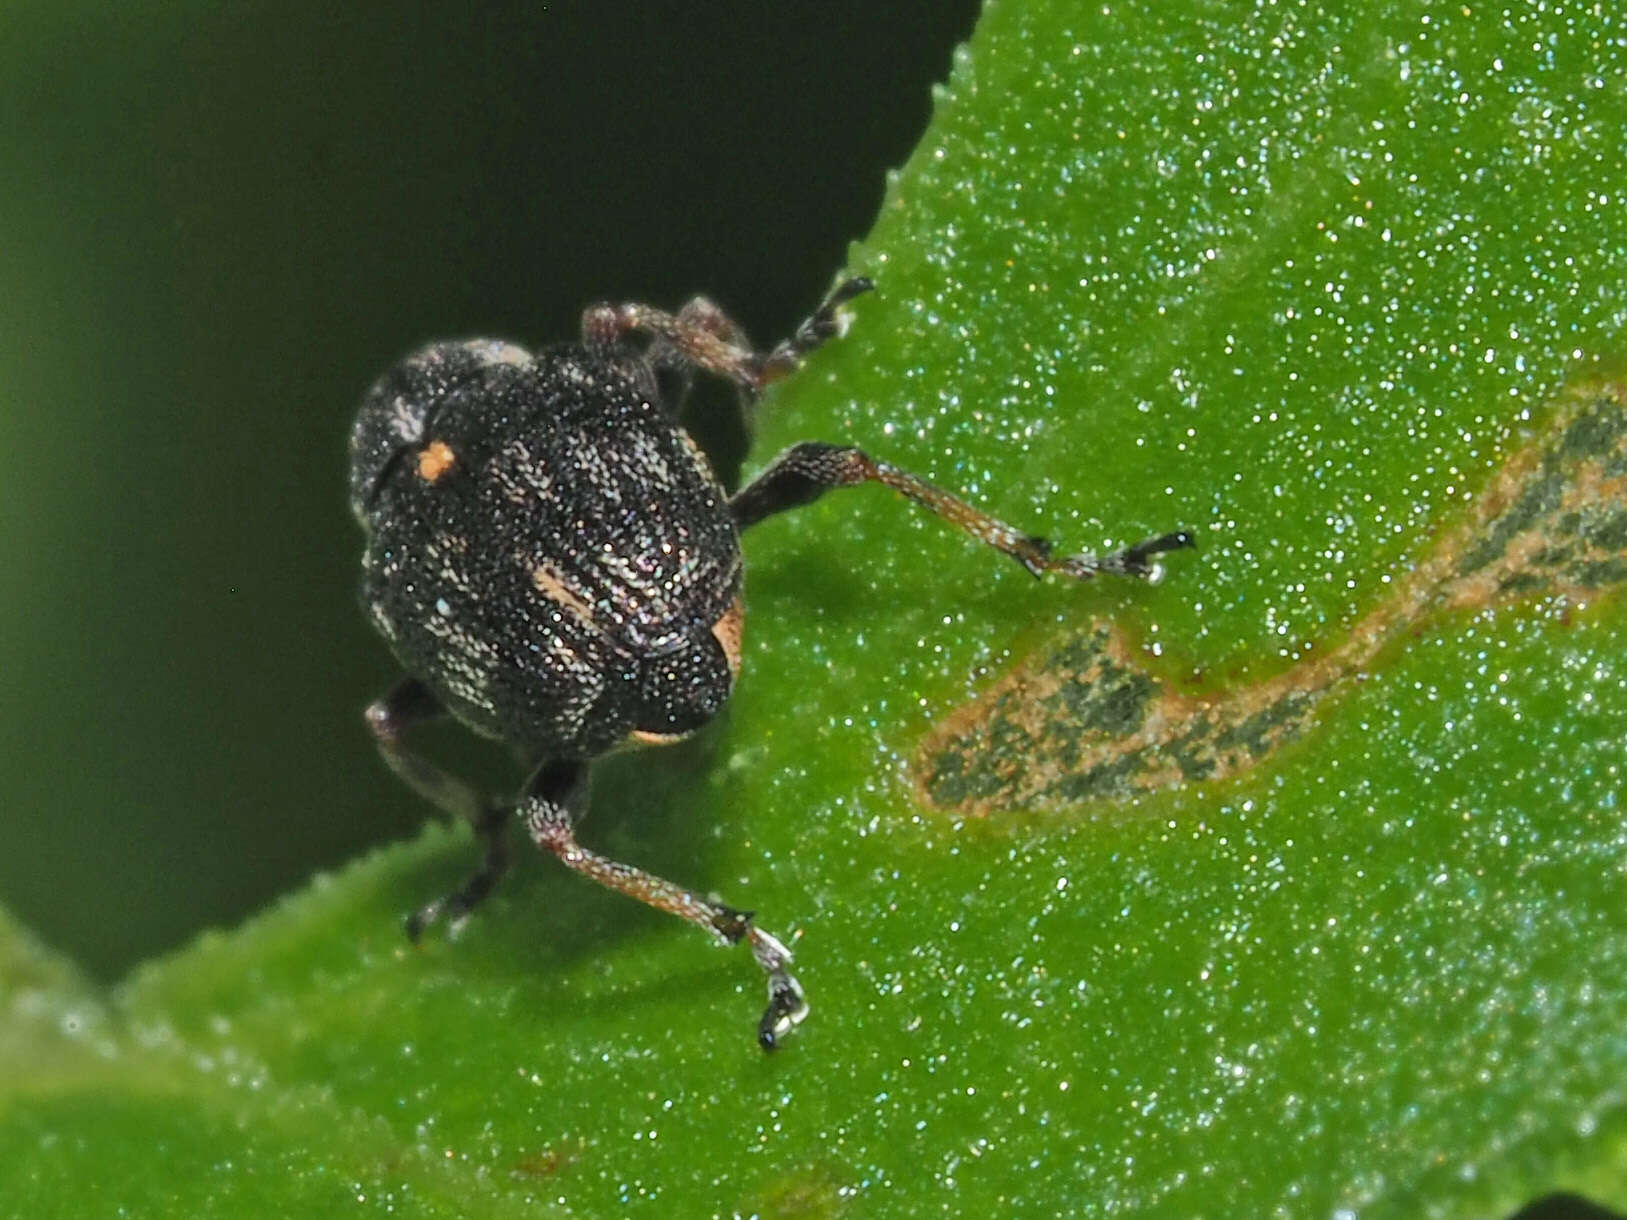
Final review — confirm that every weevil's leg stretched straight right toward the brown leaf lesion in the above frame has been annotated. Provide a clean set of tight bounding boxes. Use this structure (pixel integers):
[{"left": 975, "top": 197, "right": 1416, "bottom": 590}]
[{"left": 729, "top": 441, "right": 1193, "bottom": 581}]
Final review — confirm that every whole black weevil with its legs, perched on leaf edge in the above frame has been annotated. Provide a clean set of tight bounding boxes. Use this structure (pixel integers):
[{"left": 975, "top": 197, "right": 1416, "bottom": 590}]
[{"left": 350, "top": 278, "right": 1191, "bottom": 1049}]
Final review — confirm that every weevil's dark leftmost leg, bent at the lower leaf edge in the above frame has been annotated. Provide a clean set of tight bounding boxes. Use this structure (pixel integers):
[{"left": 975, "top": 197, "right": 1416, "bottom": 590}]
[{"left": 368, "top": 678, "right": 509, "bottom": 940}]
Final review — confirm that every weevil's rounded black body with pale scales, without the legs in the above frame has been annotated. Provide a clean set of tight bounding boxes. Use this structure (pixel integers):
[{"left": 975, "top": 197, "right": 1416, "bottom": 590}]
[{"left": 351, "top": 342, "right": 740, "bottom": 758}]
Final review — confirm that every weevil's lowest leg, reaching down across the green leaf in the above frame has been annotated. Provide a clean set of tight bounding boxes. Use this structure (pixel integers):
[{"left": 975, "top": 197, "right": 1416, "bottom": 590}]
[{"left": 519, "top": 760, "right": 809, "bottom": 1051}]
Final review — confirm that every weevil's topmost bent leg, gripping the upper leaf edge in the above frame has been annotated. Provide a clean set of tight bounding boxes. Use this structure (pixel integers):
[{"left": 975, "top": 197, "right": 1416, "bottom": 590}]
[{"left": 582, "top": 277, "right": 874, "bottom": 394}]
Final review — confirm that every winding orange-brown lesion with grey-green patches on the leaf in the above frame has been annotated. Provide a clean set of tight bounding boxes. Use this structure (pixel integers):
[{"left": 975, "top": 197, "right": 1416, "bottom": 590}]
[{"left": 911, "top": 384, "right": 1627, "bottom": 813}]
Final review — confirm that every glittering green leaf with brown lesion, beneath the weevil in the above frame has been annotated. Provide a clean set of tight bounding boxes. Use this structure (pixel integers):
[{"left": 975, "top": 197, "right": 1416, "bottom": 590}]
[{"left": 0, "top": 0, "right": 1627, "bottom": 1215}]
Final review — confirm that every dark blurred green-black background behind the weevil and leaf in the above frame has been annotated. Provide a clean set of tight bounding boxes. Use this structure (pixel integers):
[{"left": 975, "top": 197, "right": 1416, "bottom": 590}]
[{"left": 0, "top": 0, "right": 976, "bottom": 978}]
